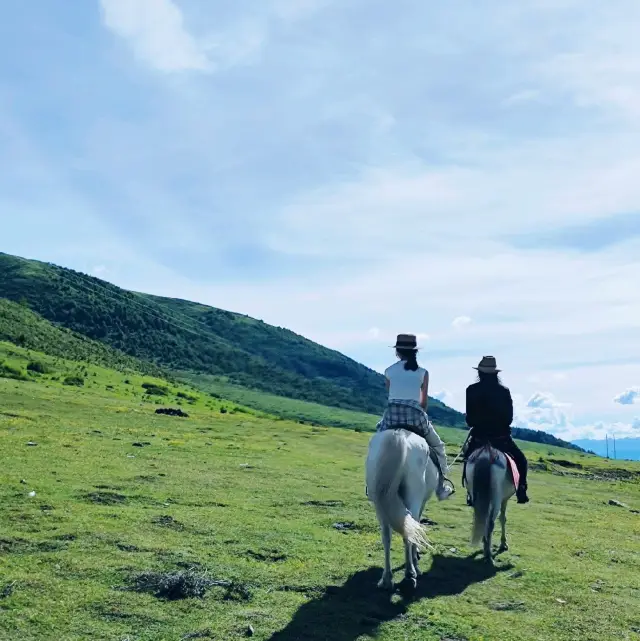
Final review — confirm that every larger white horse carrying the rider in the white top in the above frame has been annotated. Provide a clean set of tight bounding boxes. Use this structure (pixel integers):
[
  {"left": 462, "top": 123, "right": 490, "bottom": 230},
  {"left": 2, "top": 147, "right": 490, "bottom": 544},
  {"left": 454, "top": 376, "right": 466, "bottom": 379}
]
[{"left": 366, "top": 429, "right": 439, "bottom": 590}]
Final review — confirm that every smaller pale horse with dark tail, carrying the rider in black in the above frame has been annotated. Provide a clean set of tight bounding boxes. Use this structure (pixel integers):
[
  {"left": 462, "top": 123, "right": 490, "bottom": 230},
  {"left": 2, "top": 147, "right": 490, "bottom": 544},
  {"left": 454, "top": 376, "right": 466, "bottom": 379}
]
[{"left": 465, "top": 445, "right": 516, "bottom": 565}]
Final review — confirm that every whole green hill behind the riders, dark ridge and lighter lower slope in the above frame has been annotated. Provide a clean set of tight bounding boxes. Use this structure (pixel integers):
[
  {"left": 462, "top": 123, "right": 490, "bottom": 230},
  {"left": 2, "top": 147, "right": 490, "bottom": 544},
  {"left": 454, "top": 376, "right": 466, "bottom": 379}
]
[{"left": 0, "top": 253, "right": 592, "bottom": 449}]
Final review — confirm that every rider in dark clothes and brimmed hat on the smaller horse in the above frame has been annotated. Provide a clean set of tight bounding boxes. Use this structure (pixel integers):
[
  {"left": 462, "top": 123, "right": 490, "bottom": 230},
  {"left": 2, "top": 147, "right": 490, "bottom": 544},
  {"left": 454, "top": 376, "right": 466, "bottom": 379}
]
[{"left": 466, "top": 356, "right": 529, "bottom": 503}]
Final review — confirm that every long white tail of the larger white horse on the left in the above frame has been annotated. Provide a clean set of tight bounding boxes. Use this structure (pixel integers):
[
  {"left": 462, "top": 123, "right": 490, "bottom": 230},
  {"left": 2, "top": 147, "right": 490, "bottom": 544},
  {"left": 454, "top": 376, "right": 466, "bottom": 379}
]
[{"left": 369, "top": 430, "right": 429, "bottom": 547}]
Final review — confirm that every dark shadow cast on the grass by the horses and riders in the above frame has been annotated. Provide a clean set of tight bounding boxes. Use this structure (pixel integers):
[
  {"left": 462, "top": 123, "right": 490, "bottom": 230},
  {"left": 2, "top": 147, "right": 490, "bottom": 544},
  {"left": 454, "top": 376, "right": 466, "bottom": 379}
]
[{"left": 269, "top": 554, "right": 513, "bottom": 641}]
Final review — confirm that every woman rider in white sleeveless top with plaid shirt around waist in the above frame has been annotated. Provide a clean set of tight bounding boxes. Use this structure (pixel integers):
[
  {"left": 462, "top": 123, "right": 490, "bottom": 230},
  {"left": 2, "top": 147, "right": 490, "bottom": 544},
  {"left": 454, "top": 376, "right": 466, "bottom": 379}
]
[{"left": 378, "top": 334, "right": 453, "bottom": 501}]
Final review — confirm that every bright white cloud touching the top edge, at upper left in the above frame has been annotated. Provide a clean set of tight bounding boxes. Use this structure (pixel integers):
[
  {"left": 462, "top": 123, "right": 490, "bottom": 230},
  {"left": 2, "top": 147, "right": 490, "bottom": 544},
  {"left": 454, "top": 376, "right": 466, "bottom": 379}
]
[{"left": 100, "top": 0, "right": 211, "bottom": 72}]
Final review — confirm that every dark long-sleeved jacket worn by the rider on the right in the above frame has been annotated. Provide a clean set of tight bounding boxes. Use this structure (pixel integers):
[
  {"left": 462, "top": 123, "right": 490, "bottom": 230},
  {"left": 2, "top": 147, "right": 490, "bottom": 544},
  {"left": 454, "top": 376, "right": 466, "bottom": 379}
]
[{"left": 466, "top": 382, "right": 513, "bottom": 438}]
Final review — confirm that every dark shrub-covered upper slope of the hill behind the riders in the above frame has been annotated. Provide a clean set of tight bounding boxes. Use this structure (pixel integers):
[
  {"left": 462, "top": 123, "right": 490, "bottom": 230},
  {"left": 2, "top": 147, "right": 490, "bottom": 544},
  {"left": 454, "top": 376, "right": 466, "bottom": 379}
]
[{"left": 0, "top": 253, "right": 463, "bottom": 425}]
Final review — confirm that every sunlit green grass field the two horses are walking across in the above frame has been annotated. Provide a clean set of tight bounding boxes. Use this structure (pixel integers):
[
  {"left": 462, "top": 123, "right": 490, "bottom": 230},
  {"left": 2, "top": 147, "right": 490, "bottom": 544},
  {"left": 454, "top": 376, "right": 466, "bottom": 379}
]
[{"left": 0, "top": 344, "right": 640, "bottom": 641}]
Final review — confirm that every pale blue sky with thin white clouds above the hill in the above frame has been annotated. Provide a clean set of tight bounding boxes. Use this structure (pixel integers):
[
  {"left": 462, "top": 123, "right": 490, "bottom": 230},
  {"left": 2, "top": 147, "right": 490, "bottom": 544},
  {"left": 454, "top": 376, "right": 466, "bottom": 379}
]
[{"left": 0, "top": 0, "right": 640, "bottom": 439}]
